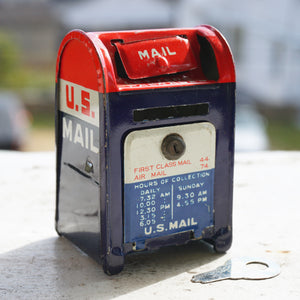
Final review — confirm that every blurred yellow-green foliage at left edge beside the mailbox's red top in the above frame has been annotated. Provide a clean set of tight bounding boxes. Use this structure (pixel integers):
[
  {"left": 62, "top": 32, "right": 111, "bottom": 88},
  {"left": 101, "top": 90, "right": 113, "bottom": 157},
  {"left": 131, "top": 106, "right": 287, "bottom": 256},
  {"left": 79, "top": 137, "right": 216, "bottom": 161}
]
[{"left": 0, "top": 32, "right": 54, "bottom": 90}]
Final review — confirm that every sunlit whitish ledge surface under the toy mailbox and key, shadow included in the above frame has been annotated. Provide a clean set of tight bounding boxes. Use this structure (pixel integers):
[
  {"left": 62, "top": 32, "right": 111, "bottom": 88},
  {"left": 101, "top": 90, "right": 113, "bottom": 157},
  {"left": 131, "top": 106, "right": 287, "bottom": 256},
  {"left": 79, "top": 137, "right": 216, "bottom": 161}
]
[{"left": 0, "top": 151, "right": 300, "bottom": 300}]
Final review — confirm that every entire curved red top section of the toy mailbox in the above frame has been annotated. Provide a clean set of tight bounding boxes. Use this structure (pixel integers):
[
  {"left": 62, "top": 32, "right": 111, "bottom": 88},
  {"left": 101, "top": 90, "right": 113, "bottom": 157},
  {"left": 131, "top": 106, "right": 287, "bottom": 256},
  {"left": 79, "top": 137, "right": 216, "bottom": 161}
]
[{"left": 56, "top": 25, "right": 235, "bottom": 93}]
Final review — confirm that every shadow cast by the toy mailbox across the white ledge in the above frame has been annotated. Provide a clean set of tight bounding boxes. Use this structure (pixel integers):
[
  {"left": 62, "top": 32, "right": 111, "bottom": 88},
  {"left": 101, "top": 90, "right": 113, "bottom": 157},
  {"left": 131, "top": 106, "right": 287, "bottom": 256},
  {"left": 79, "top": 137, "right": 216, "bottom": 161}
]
[{"left": 0, "top": 237, "right": 221, "bottom": 299}]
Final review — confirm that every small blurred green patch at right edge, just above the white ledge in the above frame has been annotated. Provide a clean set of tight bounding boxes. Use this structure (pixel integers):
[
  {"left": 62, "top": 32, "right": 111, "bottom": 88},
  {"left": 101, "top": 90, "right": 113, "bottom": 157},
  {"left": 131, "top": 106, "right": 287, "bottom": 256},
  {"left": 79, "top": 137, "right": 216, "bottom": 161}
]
[{"left": 267, "top": 119, "right": 300, "bottom": 150}]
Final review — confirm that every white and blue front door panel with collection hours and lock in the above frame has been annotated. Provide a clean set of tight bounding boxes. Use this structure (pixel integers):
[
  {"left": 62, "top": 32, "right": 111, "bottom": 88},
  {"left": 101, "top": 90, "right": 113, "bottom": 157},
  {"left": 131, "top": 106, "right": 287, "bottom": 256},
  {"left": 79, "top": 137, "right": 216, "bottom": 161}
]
[{"left": 124, "top": 122, "right": 216, "bottom": 250}]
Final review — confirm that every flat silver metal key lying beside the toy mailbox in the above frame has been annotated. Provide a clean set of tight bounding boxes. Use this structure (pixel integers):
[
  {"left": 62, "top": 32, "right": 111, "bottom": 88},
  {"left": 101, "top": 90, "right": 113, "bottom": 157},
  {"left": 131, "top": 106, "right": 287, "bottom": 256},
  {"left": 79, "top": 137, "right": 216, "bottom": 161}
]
[{"left": 192, "top": 257, "right": 280, "bottom": 283}]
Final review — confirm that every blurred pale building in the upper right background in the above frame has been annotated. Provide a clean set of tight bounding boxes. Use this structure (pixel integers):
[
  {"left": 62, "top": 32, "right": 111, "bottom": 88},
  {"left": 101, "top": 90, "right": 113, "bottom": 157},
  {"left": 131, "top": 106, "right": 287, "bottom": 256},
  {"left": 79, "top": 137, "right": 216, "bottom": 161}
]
[{"left": 176, "top": 0, "right": 300, "bottom": 107}]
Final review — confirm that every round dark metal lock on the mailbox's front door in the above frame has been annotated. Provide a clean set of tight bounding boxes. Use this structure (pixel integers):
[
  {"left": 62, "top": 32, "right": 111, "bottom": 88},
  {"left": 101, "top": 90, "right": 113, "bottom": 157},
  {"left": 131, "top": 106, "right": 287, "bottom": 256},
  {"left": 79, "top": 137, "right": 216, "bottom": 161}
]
[{"left": 161, "top": 133, "right": 185, "bottom": 160}]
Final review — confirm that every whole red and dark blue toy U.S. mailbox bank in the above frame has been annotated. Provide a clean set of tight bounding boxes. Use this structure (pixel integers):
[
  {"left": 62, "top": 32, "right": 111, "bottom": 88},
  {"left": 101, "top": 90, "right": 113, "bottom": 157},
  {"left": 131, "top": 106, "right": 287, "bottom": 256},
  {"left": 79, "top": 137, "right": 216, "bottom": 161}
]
[{"left": 56, "top": 26, "right": 235, "bottom": 274}]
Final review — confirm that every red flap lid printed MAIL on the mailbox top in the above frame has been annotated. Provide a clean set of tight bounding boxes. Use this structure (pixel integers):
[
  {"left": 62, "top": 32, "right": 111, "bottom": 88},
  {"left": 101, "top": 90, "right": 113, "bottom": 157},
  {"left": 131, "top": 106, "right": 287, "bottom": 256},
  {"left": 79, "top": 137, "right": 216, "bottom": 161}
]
[{"left": 114, "top": 36, "right": 198, "bottom": 79}]
